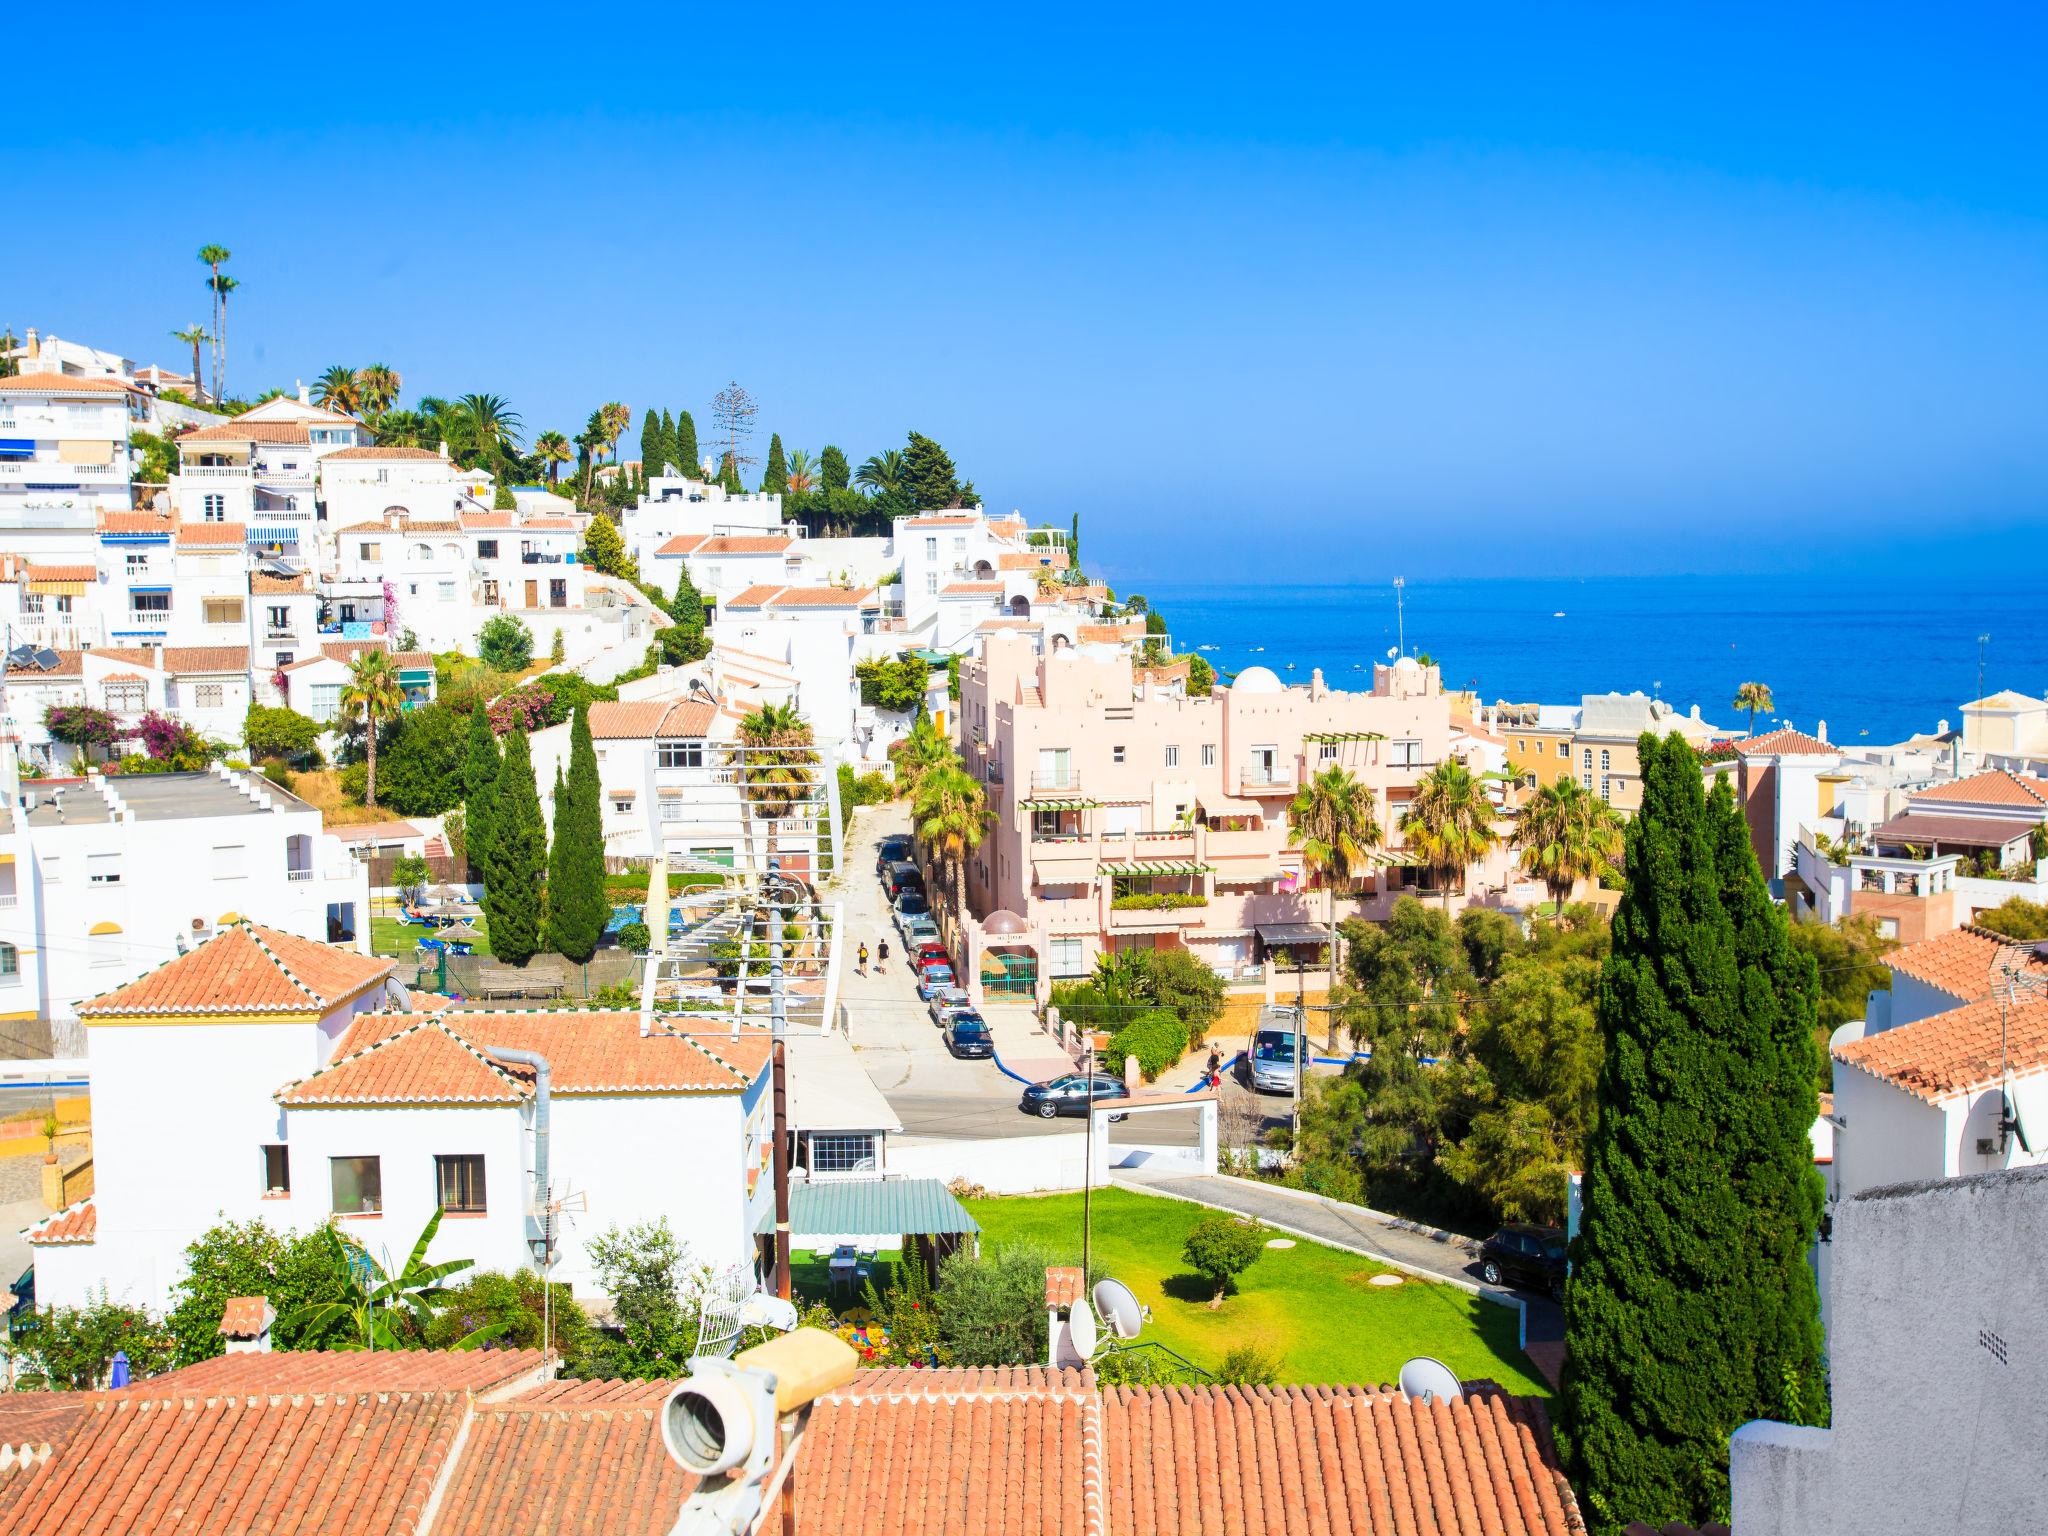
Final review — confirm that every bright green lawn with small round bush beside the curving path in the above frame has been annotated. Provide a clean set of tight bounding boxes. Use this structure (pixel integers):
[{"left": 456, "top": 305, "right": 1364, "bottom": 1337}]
[{"left": 967, "top": 1190, "right": 1548, "bottom": 1395}]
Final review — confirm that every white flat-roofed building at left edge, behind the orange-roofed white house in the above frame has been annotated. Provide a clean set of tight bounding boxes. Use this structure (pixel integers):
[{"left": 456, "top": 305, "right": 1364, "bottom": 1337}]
[{"left": 0, "top": 768, "right": 369, "bottom": 1028}]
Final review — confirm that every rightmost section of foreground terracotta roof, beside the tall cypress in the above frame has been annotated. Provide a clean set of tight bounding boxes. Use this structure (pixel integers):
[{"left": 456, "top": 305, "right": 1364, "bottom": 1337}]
[{"left": 1102, "top": 1384, "right": 1585, "bottom": 1536}]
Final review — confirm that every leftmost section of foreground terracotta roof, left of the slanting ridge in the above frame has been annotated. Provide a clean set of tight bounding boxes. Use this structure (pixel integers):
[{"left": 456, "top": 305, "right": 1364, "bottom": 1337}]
[{"left": 6, "top": 1392, "right": 469, "bottom": 1536}]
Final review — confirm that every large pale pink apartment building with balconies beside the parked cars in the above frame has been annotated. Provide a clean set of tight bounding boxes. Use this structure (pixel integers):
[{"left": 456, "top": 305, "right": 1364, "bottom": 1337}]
[{"left": 961, "top": 635, "right": 1542, "bottom": 991}]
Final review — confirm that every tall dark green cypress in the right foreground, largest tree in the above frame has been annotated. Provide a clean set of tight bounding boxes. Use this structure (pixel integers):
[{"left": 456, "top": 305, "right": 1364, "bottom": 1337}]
[{"left": 1559, "top": 735, "right": 1821, "bottom": 1532}]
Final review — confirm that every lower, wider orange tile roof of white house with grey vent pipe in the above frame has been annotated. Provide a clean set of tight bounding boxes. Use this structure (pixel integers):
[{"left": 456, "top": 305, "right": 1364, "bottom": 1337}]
[{"left": 276, "top": 1008, "right": 768, "bottom": 1108}]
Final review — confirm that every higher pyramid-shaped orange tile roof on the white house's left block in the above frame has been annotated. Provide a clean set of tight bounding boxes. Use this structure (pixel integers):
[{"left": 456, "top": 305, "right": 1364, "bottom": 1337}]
[{"left": 78, "top": 922, "right": 397, "bottom": 1018}]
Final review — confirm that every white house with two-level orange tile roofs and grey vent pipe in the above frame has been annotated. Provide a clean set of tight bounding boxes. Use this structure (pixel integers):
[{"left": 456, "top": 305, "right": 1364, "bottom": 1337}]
[{"left": 31, "top": 924, "right": 774, "bottom": 1309}]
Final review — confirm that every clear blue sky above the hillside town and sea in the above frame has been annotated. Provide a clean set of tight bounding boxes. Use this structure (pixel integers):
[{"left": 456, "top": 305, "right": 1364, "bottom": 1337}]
[{"left": 0, "top": 2, "right": 2048, "bottom": 581}]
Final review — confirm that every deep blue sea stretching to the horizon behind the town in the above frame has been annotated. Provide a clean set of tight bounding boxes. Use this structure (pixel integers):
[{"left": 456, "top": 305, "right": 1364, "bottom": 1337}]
[{"left": 1118, "top": 569, "right": 2048, "bottom": 743}]
